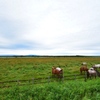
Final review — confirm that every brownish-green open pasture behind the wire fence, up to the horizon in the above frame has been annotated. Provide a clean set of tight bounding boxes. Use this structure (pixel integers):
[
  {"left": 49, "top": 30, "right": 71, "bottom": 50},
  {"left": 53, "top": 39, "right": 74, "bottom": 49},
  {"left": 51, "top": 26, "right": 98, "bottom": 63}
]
[{"left": 0, "top": 57, "right": 100, "bottom": 82}]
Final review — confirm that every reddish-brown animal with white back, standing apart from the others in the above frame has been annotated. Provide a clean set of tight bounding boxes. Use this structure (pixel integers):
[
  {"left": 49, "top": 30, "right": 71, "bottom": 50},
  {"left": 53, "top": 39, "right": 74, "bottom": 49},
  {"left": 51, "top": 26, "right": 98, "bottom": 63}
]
[{"left": 52, "top": 67, "right": 63, "bottom": 78}]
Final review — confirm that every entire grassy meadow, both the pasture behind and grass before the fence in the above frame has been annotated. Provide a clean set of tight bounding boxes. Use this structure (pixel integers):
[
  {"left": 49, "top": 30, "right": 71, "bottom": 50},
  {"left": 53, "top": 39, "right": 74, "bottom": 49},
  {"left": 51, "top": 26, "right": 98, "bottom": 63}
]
[{"left": 0, "top": 57, "right": 100, "bottom": 100}]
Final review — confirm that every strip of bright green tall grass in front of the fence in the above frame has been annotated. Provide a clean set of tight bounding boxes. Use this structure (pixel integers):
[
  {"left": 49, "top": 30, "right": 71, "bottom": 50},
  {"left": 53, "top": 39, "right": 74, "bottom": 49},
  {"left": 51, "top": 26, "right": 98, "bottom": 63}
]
[{"left": 0, "top": 80, "right": 100, "bottom": 100}]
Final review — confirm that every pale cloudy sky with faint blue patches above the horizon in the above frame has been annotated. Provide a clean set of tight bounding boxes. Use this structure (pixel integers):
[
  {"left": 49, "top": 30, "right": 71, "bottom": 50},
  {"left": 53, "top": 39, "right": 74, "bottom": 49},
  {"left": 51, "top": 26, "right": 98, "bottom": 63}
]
[{"left": 0, "top": 0, "right": 100, "bottom": 55}]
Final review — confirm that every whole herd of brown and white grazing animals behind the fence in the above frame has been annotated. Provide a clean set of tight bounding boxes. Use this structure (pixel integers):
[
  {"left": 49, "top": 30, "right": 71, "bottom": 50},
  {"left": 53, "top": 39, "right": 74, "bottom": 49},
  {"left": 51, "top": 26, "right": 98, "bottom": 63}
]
[{"left": 52, "top": 62, "right": 100, "bottom": 78}]
